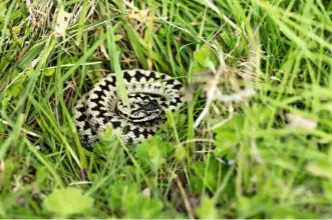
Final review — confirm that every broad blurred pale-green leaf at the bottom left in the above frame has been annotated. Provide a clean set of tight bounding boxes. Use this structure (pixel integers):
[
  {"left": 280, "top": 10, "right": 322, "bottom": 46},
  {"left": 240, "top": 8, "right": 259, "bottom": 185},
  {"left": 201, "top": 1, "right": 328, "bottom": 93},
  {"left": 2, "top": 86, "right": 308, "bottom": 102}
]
[{"left": 43, "top": 187, "right": 93, "bottom": 217}]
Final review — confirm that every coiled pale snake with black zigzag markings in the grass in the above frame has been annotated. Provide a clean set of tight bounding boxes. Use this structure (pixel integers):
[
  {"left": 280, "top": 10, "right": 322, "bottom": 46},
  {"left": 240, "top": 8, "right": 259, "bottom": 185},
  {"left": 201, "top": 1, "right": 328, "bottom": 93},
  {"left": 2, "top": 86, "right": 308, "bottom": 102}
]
[{"left": 73, "top": 69, "right": 184, "bottom": 150}]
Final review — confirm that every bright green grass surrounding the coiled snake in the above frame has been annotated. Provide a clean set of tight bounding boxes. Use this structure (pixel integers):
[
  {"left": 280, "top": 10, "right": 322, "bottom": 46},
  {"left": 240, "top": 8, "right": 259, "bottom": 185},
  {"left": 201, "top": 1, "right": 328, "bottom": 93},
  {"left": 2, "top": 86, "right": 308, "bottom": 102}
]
[{"left": 0, "top": 0, "right": 332, "bottom": 218}]
